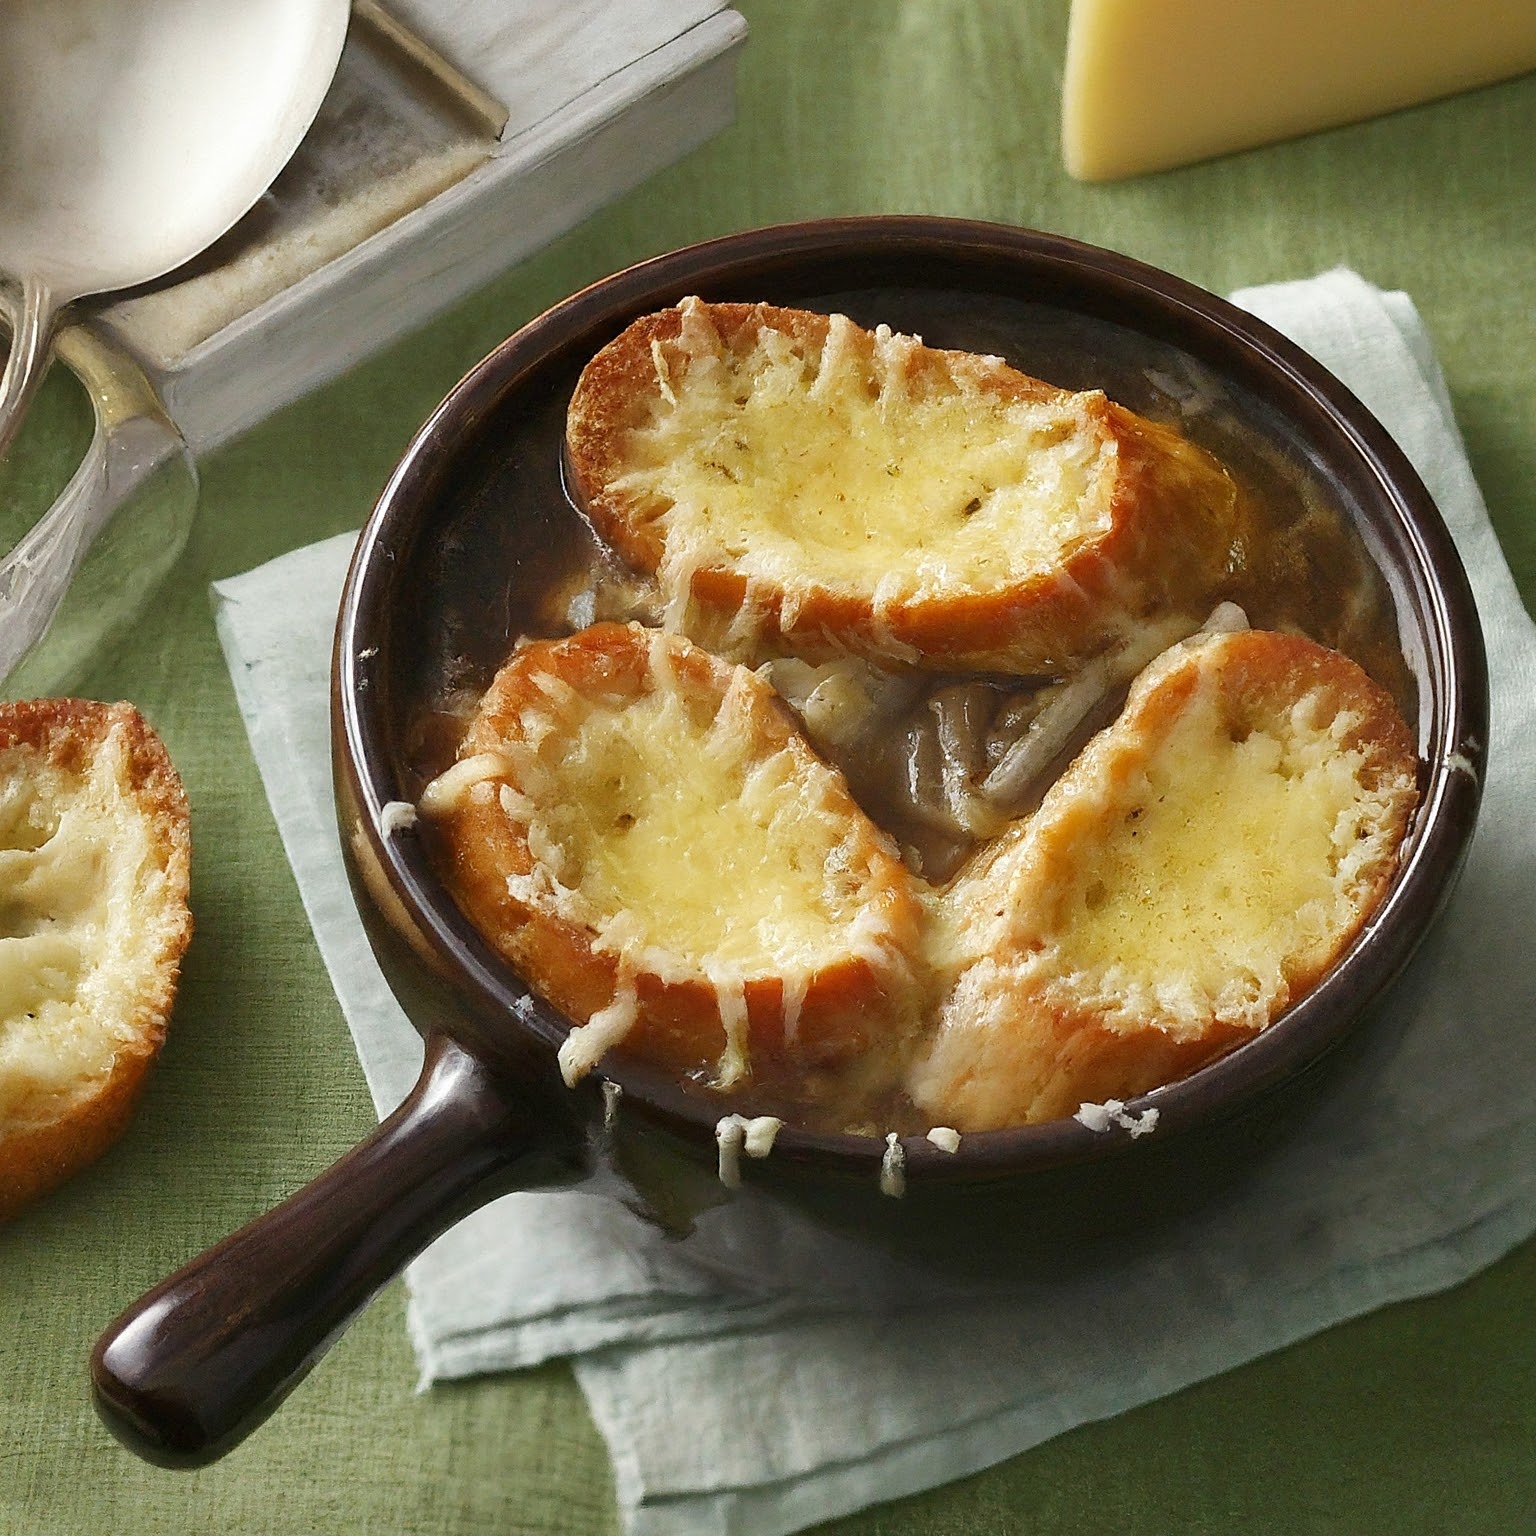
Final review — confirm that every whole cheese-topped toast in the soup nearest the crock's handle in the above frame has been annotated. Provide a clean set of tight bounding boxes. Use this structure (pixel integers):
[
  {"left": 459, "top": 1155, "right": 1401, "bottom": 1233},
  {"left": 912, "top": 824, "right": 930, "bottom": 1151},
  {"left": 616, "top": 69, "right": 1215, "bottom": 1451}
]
[{"left": 421, "top": 624, "right": 919, "bottom": 1086}]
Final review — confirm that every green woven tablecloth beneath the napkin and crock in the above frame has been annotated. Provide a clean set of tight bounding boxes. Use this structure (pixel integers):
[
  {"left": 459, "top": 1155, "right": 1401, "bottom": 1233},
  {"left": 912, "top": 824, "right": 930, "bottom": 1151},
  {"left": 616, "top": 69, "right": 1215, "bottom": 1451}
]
[{"left": 0, "top": 0, "right": 1536, "bottom": 1536}]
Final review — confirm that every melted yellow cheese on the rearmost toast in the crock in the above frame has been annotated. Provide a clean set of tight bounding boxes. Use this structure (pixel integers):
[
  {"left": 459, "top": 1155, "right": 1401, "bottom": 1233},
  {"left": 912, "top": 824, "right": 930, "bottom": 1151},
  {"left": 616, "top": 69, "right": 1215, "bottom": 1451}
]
[{"left": 614, "top": 306, "right": 1117, "bottom": 607}]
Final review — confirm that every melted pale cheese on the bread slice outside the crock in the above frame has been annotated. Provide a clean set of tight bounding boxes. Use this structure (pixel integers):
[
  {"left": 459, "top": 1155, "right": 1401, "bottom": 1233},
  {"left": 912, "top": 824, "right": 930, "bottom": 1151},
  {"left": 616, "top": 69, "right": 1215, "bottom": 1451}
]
[{"left": 0, "top": 731, "right": 155, "bottom": 1123}]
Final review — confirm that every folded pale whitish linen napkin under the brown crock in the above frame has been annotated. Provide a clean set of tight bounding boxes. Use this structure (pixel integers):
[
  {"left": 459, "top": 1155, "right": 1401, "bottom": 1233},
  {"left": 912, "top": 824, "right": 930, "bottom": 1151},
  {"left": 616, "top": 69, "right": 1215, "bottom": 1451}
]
[{"left": 215, "top": 270, "right": 1536, "bottom": 1536}]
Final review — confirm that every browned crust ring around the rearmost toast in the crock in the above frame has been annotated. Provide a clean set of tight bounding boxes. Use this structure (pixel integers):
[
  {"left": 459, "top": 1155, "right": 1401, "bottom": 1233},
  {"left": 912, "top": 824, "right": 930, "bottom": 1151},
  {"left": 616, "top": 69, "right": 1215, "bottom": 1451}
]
[{"left": 565, "top": 300, "right": 1253, "bottom": 673}]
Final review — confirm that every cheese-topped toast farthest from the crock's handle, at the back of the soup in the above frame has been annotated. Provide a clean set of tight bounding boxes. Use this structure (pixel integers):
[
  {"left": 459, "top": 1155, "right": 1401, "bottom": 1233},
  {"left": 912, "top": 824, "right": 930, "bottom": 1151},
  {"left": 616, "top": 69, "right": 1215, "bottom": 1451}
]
[{"left": 565, "top": 300, "right": 1249, "bottom": 671}]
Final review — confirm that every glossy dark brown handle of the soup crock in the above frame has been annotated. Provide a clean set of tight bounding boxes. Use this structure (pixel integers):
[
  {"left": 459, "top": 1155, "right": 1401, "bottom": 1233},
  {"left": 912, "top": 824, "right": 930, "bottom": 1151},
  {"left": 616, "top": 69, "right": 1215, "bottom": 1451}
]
[{"left": 91, "top": 1035, "right": 581, "bottom": 1467}]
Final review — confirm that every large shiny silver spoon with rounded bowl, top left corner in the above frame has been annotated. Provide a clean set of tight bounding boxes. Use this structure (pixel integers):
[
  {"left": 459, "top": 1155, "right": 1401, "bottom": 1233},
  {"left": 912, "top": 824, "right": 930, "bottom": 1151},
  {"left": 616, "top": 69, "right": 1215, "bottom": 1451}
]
[{"left": 0, "top": 0, "right": 349, "bottom": 455}]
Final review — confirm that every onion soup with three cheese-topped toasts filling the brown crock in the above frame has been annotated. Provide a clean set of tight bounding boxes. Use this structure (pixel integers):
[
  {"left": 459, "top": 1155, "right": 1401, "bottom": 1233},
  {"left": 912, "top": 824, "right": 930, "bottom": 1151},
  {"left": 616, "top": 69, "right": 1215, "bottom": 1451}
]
[{"left": 418, "top": 300, "right": 1416, "bottom": 1137}]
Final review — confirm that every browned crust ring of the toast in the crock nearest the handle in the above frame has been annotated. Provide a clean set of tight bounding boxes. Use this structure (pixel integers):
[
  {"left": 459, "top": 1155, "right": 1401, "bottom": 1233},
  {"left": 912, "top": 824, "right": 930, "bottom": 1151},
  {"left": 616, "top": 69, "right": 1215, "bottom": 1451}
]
[{"left": 421, "top": 624, "right": 919, "bottom": 1086}]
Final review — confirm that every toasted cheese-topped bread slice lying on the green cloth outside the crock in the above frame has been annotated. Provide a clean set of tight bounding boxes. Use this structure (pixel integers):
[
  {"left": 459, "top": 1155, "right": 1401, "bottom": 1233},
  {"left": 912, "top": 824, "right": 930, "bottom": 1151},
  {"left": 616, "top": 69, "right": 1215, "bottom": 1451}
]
[{"left": 0, "top": 699, "right": 192, "bottom": 1218}]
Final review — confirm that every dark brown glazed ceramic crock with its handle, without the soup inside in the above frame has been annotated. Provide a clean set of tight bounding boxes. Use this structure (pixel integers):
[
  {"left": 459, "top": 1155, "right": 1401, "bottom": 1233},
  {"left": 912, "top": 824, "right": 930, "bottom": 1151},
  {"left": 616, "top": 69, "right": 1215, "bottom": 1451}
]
[{"left": 92, "top": 217, "right": 1487, "bottom": 1465}]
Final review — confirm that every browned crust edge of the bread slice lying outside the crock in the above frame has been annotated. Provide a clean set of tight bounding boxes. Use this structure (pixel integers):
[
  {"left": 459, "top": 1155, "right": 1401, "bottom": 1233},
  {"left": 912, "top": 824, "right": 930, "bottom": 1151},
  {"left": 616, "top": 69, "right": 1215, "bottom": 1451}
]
[{"left": 0, "top": 699, "right": 192, "bottom": 1220}]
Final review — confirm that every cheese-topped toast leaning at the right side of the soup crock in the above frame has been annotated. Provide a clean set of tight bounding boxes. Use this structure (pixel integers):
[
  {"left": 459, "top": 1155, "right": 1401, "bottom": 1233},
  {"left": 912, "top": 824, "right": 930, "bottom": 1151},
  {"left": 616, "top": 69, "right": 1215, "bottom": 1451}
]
[{"left": 911, "top": 631, "right": 1416, "bottom": 1130}]
